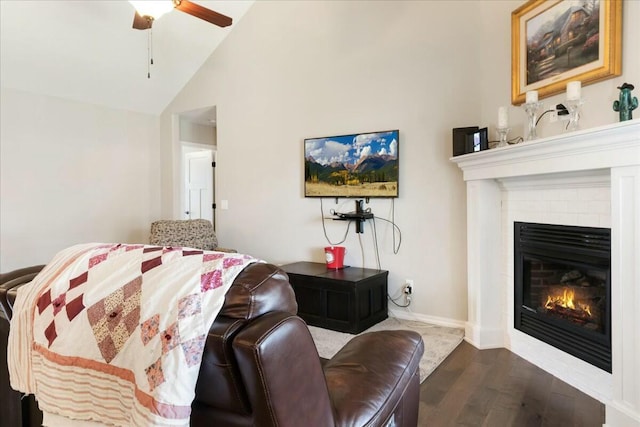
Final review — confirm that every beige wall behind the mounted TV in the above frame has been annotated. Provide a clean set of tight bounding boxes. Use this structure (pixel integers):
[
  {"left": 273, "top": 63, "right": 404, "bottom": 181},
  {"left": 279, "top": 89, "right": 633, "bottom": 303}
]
[{"left": 162, "top": 1, "right": 481, "bottom": 319}]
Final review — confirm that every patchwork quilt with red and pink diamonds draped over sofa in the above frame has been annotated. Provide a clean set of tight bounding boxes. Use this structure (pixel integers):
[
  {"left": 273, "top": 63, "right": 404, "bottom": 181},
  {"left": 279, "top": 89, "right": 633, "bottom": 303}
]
[{"left": 8, "top": 244, "right": 258, "bottom": 426}]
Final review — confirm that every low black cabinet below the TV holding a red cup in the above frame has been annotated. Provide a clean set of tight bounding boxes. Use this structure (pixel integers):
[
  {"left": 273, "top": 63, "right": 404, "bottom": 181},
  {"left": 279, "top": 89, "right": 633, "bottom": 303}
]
[{"left": 281, "top": 262, "right": 389, "bottom": 334}]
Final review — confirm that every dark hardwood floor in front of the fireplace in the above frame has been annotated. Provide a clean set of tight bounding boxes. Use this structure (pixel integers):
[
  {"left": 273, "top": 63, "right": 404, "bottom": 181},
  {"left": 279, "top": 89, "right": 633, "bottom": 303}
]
[{"left": 418, "top": 341, "right": 604, "bottom": 427}]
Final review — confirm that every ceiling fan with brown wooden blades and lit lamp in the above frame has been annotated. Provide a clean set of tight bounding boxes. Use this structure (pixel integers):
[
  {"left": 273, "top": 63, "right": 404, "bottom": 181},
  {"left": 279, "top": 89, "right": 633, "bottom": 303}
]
[{"left": 130, "top": 0, "right": 232, "bottom": 30}]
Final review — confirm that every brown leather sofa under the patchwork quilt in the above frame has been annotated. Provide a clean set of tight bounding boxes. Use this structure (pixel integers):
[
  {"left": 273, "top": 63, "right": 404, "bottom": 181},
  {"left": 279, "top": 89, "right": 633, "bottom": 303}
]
[{"left": 0, "top": 263, "right": 424, "bottom": 427}]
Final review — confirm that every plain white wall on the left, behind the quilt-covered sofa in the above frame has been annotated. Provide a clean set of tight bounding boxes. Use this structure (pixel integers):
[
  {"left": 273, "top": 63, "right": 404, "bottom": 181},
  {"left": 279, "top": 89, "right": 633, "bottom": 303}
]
[{"left": 0, "top": 88, "right": 160, "bottom": 272}]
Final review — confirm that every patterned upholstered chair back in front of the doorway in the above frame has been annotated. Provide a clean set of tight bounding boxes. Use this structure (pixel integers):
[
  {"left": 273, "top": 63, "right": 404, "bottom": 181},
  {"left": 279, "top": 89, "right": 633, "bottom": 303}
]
[{"left": 149, "top": 219, "right": 237, "bottom": 252}]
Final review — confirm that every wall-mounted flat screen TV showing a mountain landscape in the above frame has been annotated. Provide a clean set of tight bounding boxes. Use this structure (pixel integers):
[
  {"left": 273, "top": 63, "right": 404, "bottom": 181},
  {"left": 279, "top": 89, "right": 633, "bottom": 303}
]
[{"left": 304, "top": 130, "right": 399, "bottom": 198}]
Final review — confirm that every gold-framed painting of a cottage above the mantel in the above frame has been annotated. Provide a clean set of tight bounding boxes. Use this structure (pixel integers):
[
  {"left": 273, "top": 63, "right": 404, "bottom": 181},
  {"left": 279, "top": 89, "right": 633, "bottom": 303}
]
[{"left": 511, "top": 0, "right": 622, "bottom": 105}]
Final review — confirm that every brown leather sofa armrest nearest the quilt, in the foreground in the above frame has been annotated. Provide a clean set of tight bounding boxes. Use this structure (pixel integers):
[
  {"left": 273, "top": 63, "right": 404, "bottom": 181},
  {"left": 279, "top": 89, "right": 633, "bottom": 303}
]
[{"left": 233, "top": 312, "right": 334, "bottom": 427}]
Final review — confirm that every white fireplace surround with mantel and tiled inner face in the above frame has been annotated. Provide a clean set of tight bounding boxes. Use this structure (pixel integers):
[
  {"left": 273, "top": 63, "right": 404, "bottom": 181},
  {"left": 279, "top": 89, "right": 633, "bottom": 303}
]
[{"left": 451, "top": 119, "right": 640, "bottom": 427}]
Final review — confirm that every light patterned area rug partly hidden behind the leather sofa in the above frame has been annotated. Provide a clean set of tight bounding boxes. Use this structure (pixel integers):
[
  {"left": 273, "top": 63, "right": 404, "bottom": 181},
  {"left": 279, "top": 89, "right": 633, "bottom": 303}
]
[{"left": 309, "top": 317, "right": 464, "bottom": 382}]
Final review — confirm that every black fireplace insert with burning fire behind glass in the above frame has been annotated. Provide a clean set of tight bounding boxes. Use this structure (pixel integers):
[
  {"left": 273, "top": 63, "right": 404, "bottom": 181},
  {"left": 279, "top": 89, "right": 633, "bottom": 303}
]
[{"left": 514, "top": 222, "right": 611, "bottom": 372}]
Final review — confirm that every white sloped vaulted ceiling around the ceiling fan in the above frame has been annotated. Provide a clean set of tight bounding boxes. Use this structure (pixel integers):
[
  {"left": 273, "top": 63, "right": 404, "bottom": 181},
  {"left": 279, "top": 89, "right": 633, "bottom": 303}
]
[{"left": 0, "top": 0, "right": 253, "bottom": 114}]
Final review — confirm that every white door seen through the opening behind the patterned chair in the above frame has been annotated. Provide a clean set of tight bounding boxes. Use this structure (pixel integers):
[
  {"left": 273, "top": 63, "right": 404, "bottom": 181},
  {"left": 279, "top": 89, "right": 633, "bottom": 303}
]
[{"left": 184, "top": 150, "right": 213, "bottom": 222}]
